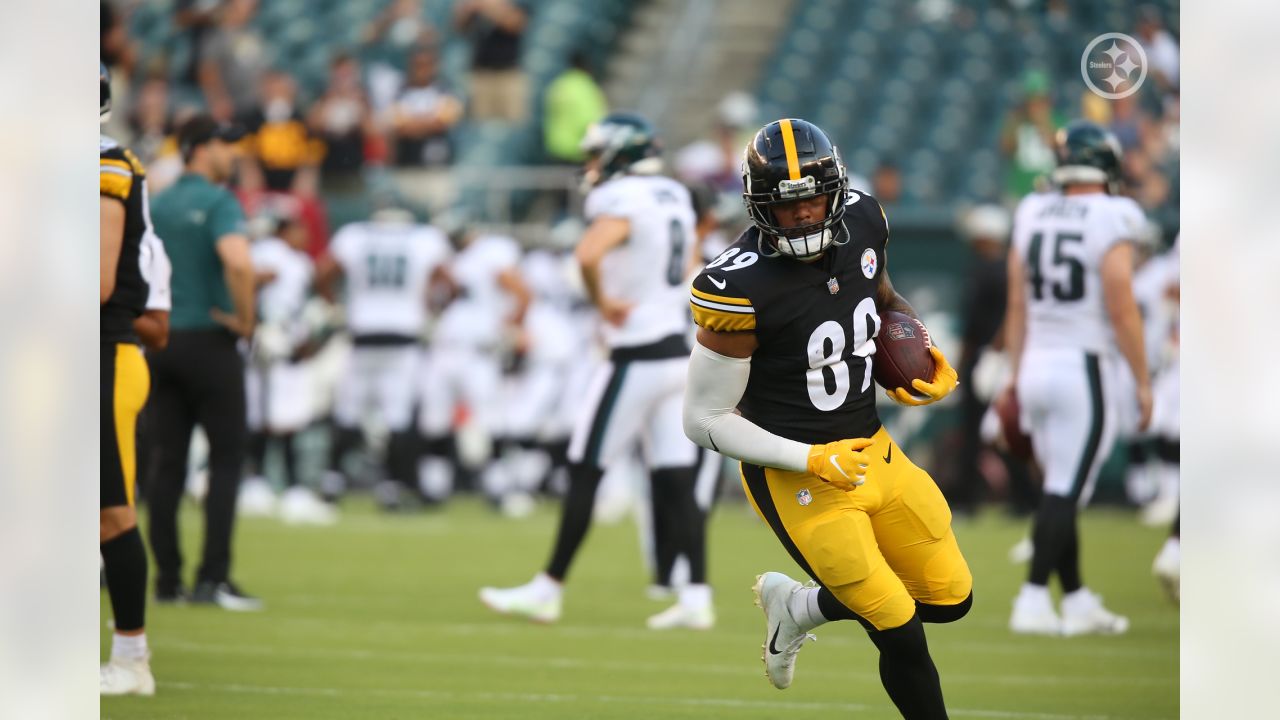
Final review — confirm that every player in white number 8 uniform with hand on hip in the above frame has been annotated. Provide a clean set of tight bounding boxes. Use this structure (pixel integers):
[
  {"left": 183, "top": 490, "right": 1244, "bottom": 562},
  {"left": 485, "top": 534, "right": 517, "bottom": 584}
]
[{"left": 480, "top": 113, "right": 714, "bottom": 629}]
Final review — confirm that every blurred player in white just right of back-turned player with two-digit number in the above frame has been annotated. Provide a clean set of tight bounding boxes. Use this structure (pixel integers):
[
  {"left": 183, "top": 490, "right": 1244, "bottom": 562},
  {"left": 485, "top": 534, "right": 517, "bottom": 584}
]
[{"left": 417, "top": 229, "right": 529, "bottom": 501}]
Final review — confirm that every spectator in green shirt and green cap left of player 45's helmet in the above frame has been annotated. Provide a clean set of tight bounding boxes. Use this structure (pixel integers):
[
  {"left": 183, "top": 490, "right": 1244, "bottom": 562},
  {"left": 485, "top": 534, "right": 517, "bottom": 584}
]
[{"left": 1000, "top": 70, "right": 1064, "bottom": 202}]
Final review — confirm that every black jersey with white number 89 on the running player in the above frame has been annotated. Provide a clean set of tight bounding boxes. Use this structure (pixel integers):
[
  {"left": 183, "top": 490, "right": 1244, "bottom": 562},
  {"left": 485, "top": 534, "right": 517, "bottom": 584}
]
[{"left": 690, "top": 190, "right": 888, "bottom": 443}]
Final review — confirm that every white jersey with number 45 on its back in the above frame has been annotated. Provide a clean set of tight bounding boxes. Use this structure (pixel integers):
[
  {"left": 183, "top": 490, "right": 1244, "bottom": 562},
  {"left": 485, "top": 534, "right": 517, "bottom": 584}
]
[{"left": 1012, "top": 192, "right": 1146, "bottom": 355}]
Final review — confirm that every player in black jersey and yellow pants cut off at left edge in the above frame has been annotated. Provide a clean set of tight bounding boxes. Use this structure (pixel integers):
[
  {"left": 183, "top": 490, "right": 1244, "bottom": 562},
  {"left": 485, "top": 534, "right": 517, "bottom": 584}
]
[{"left": 97, "top": 64, "right": 156, "bottom": 694}]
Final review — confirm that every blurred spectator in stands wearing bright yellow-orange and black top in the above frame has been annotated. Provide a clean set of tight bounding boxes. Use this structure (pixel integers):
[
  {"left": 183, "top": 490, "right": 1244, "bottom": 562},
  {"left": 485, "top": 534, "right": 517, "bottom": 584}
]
[{"left": 241, "top": 70, "right": 324, "bottom": 196}]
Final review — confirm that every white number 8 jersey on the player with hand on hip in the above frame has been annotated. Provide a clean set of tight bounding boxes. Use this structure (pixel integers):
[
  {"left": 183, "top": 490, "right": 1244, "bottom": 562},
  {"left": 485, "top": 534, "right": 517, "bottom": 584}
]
[{"left": 585, "top": 170, "right": 694, "bottom": 347}]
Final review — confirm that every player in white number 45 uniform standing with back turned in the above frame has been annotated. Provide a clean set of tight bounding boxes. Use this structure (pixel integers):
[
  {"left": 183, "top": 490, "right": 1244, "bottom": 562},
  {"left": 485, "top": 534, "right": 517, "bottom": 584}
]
[{"left": 1006, "top": 120, "right": 1152, "bottom": 635}]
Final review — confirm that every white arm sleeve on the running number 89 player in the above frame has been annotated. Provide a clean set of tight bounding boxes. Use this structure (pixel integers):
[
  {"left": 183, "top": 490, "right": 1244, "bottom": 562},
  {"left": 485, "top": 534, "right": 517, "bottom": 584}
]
[{"left": 685, "top": 341, "right": 809, "bottom": 471}]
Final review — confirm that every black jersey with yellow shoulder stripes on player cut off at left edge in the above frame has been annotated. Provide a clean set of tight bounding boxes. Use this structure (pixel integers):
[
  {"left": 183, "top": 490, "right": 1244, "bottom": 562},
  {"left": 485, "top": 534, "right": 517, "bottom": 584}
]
[{"left": 99, "top": 136, "right": 151, "bottom": 342}]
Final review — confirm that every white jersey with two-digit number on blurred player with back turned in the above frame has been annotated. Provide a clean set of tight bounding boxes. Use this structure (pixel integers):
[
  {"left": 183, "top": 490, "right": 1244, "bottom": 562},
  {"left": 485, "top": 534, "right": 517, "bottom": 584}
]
[{"left": 330, "top": 222, "right": 449, "bottom": 337}]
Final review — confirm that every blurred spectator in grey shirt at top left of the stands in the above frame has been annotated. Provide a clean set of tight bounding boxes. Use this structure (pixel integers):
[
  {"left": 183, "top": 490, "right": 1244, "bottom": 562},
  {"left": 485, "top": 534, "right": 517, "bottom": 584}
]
[{"left": 198, "top": 0, "right": 266, "bottom": 122}]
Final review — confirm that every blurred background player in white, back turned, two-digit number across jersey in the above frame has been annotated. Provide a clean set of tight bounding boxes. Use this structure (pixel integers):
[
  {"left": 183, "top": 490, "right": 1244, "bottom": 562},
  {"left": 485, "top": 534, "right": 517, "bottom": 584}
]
[{"left": 316, "top": 208, "right": 451, "bottom": 507}]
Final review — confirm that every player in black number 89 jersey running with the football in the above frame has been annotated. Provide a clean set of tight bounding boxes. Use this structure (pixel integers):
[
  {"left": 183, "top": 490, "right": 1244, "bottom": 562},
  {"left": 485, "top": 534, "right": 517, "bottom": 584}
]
[{"left": 684, "top": 119, "right": 973, "bottom": 719}]
